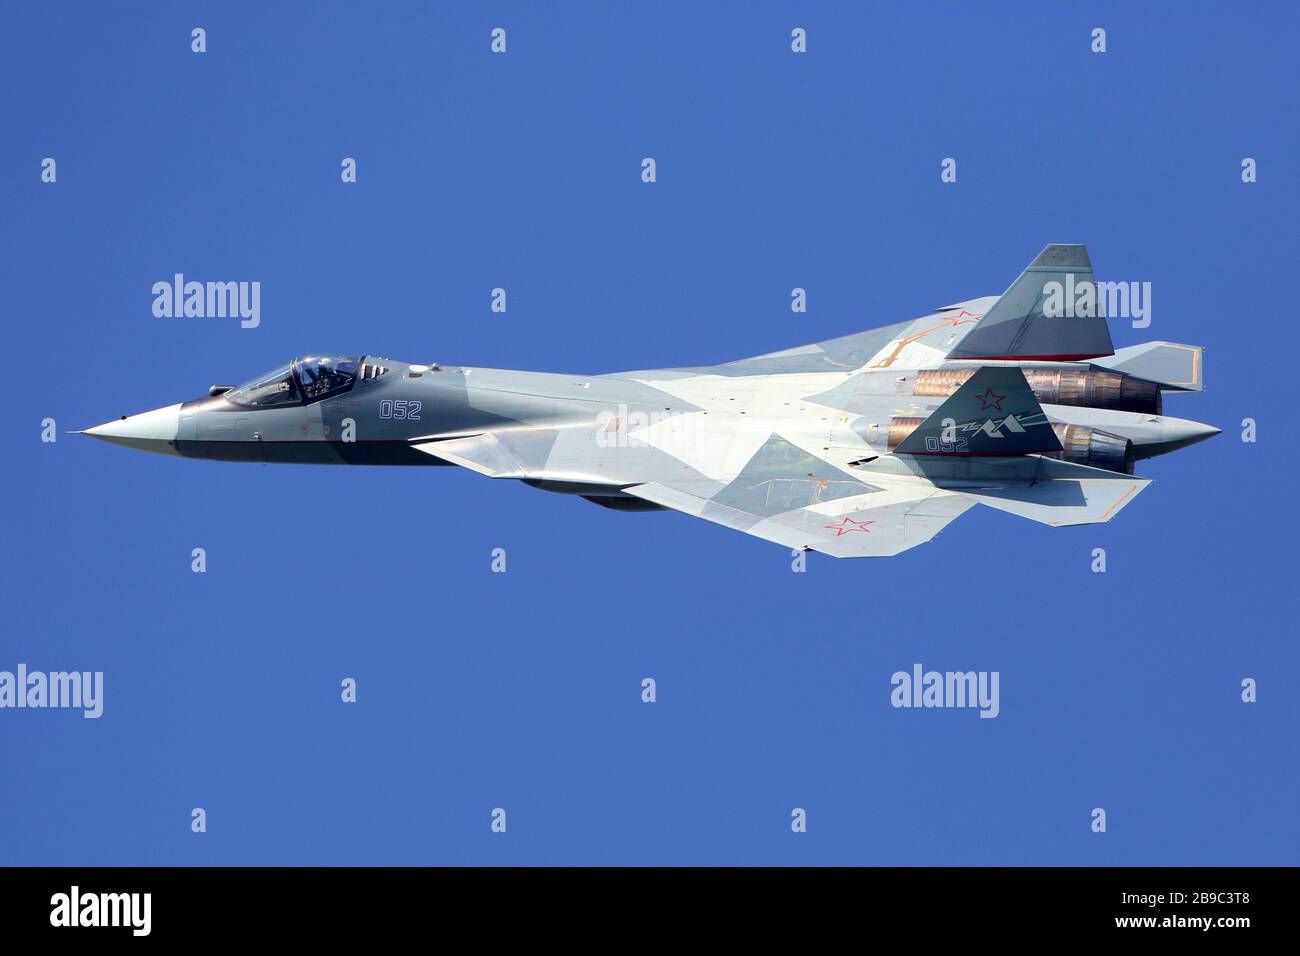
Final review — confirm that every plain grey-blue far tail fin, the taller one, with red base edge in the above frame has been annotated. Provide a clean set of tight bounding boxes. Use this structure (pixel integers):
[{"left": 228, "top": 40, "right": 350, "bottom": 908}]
[{"left": 948, "top": 246, "right": 1114, "bottom": 362}]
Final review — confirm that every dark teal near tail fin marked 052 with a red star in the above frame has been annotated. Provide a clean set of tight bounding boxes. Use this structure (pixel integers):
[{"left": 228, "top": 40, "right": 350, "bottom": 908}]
[{"left": 893, "top": 365, "right": 1061, "bottom": 455}]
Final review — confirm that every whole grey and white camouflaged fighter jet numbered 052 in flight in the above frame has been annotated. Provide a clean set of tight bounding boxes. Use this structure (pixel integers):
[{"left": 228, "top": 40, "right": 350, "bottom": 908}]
[{"left": 86, "top": 245, "right": 1219, "bottom": 558}]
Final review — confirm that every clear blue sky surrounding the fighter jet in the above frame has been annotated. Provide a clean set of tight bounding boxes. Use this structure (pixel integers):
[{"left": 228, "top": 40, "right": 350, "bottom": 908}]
[{"left": 0, "top": 3, "right": 1300, "bottom": 865}]
